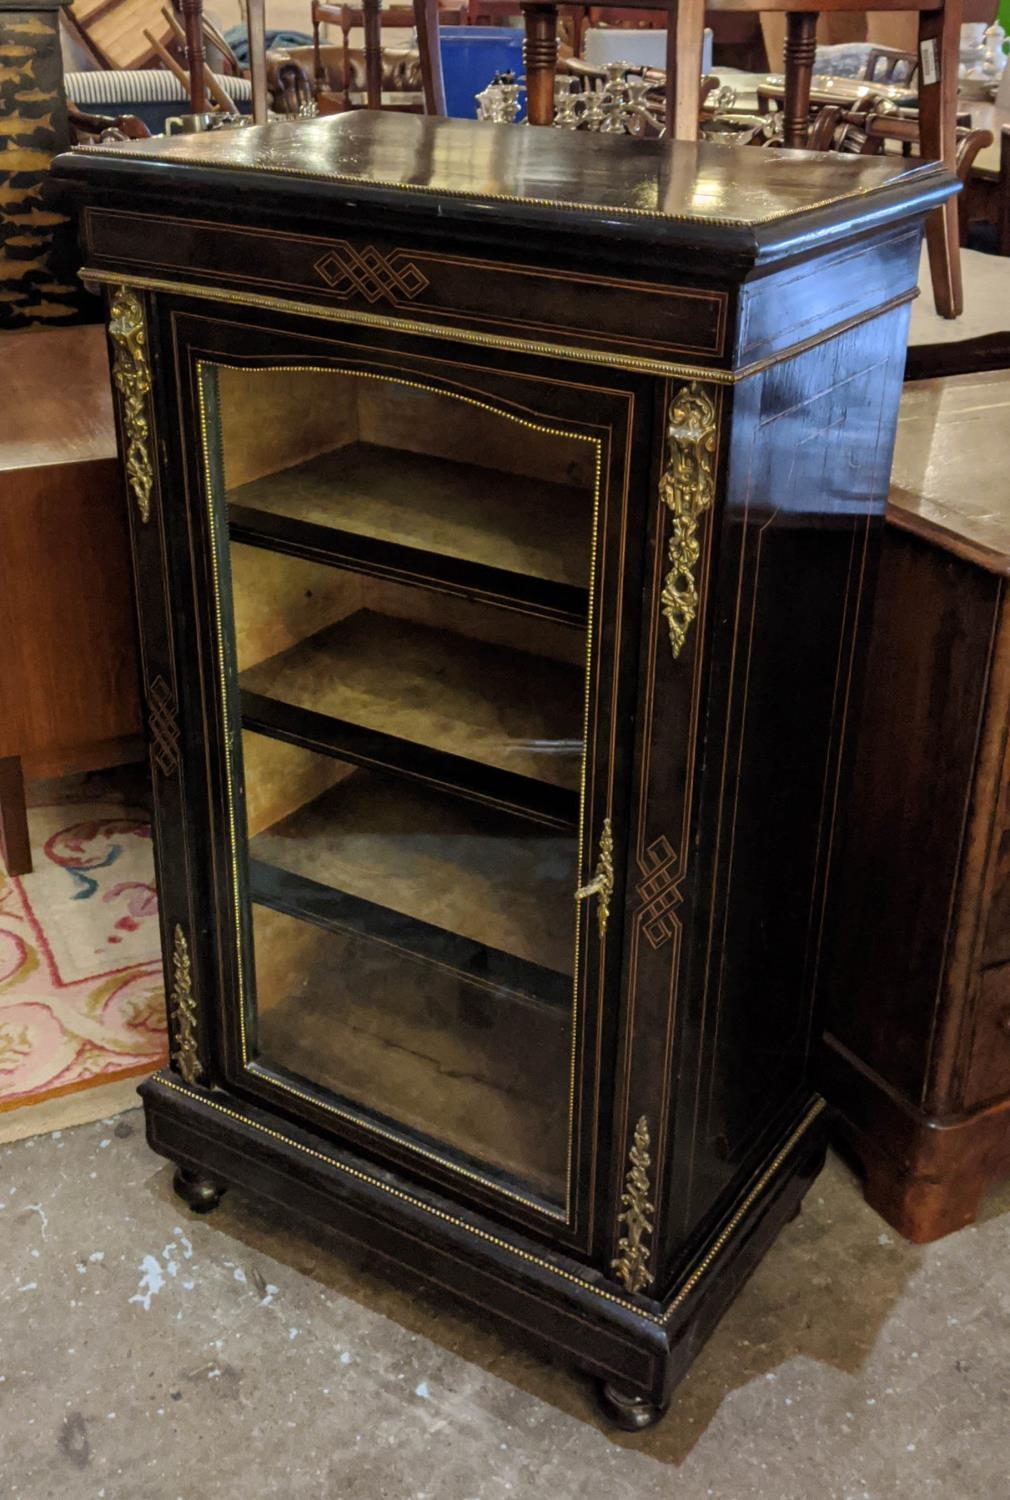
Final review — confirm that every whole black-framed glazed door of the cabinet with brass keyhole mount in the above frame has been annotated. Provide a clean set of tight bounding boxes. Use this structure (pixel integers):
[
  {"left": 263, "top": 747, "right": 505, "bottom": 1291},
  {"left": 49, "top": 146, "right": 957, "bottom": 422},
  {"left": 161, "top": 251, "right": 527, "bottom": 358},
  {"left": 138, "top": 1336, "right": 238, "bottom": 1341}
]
[{"left": 132, "top": 292, "right": 651, "bottom": 1248}]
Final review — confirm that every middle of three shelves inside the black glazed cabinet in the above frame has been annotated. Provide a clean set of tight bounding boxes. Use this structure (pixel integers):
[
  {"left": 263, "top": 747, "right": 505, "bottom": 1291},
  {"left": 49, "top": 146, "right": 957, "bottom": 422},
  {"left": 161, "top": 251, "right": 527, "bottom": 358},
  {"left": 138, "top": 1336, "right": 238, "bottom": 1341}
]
[{"left": 239, "top": 609, "right": 582, "bottom": 828}]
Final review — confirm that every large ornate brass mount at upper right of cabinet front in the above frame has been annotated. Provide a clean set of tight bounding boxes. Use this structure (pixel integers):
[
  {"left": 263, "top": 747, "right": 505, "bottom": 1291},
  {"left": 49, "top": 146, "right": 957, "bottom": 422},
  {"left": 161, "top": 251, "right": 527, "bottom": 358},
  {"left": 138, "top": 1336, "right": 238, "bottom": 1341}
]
[{"left": 659, "top": 381, "right": 716, "bottom": 657}]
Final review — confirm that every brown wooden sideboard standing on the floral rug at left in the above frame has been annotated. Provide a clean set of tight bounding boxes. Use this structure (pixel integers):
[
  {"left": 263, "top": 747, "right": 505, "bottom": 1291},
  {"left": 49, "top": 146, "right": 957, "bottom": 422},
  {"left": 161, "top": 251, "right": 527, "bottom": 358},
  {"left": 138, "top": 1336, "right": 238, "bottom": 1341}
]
[{"left": 0, "top": 327, "right": 140, "bottom": 875}]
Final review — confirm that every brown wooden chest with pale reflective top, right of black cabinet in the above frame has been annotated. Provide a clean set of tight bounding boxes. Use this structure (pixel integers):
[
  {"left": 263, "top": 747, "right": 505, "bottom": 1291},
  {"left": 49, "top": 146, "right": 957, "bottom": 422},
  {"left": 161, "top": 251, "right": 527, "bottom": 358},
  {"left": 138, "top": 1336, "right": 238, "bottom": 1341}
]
[{"left": 824, "top": 371, "right": 1010, "bottom": 1242}]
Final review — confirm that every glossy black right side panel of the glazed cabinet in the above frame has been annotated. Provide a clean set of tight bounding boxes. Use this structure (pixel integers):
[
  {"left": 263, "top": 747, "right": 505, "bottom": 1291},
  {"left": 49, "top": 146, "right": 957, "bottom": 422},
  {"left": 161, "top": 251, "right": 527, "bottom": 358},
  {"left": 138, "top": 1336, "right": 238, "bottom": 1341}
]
[{"left": 663, "top": 309, "right": 906, "bottom": 1257}]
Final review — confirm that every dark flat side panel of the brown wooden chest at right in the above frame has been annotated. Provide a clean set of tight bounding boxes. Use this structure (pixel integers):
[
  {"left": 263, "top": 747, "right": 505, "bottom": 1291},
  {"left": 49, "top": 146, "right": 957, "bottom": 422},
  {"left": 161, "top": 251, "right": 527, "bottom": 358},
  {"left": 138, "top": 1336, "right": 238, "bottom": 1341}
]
[{"left": 822, "top": 530, "right": 999, "bottom": 1113}]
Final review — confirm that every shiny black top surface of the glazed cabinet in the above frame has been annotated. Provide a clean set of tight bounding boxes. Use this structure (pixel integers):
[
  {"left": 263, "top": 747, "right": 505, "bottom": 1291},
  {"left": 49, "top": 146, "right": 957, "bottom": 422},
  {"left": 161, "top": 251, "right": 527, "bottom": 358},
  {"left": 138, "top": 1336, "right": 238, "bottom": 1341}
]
[{"left": 64, "top": 111, "right": 953, "bottom": 246}]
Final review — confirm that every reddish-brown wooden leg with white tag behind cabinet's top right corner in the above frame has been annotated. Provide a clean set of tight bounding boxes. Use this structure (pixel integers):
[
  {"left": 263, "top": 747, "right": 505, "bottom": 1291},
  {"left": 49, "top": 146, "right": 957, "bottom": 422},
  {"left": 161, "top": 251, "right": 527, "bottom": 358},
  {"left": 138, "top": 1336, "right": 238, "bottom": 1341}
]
[{"left": 918, "top": 0, "right": 965, "bottom": 318}]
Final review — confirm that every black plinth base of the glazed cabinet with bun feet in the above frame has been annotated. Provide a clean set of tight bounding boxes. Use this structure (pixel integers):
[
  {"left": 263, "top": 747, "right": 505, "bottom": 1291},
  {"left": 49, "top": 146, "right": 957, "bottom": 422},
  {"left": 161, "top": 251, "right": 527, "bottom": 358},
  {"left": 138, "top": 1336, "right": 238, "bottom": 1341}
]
[{"left": 140, "top": 1073, "right": 825, "bottom": 1431}]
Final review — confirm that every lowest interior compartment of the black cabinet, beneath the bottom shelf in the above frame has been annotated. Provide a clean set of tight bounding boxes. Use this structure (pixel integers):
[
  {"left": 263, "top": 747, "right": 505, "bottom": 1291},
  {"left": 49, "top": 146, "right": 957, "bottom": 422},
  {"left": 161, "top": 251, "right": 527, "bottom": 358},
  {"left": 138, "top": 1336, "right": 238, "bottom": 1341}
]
[{"left": 252, "top": 905, "right": 572, "bottom": 1202}]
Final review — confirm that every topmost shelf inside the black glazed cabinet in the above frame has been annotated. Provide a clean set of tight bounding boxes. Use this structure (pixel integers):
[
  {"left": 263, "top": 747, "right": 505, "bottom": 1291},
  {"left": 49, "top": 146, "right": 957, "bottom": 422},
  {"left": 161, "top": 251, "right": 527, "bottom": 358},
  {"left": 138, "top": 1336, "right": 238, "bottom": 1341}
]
[{"left": 228, "top": 443, "right": 593, "bottom": 624}]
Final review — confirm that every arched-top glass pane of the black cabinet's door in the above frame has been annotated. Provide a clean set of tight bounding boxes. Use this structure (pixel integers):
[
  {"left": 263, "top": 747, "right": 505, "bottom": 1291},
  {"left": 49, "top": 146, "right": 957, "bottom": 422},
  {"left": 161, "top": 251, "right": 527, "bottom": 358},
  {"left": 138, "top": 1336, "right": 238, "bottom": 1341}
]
[{"left": 201, "top": 366, "right": 599, "bottom": 1203}]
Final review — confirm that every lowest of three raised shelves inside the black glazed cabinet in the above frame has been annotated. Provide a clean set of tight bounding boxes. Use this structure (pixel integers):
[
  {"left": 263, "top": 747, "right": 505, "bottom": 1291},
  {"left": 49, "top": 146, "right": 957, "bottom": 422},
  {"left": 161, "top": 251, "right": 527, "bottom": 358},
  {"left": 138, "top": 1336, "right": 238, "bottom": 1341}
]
[{"left": 249, "top": 770, "right": 576, "bottom": 977}]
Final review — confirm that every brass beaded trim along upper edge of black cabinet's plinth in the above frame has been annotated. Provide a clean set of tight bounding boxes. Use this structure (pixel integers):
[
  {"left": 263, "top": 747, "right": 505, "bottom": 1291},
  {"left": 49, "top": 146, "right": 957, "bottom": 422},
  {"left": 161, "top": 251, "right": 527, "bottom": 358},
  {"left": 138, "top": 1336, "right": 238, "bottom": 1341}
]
[{"left": 152, "top": 1077, "right": 825, "bottom": 1328}]
